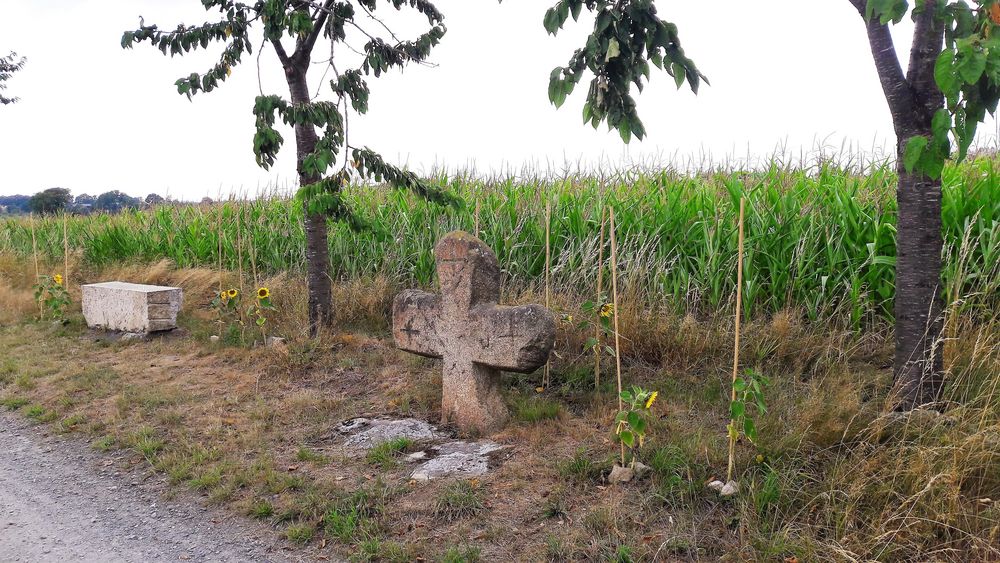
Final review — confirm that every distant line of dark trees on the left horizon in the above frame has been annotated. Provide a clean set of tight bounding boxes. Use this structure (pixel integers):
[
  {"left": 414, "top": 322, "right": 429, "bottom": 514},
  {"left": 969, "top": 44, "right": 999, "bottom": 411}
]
[{"left": 0, "top": 188, "right": 168, "bottom": 215}]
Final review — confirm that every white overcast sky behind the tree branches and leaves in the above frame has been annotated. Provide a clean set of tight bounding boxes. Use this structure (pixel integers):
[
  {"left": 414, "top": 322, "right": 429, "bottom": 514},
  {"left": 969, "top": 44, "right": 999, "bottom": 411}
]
[{"left": 0, "top": 0, "right": 996, "bottom": 199}]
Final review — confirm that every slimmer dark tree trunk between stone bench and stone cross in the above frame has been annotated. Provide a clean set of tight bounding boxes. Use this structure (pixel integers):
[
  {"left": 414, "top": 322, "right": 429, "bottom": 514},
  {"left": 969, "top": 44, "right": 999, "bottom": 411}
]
[{"left": 285, "top": 65, "right": 333, "bottom": 336}]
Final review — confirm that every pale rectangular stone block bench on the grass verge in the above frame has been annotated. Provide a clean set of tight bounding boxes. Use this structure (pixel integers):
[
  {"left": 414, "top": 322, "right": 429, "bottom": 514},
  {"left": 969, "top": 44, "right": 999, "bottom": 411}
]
[{"left": 83, "top": 281, "right": 184, "bottom": 333}]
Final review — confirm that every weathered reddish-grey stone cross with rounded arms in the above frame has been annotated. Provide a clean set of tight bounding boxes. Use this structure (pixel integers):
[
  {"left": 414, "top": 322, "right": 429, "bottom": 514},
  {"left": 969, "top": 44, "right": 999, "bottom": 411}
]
[{"left": 392, "top": 231, "right": 556, "bottom": 434}]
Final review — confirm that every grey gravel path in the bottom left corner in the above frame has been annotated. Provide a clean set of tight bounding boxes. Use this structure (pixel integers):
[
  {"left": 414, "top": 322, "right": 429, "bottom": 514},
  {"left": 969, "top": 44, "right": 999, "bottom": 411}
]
[{"left": 0, "top": 413, "right": 300, "bottom": 563}]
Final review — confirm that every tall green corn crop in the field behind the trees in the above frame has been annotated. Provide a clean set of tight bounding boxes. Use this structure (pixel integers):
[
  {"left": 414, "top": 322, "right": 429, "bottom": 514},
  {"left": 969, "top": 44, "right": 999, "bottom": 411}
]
[{"left": 0, "top": 158, "right": 1000, "bottom": 326}]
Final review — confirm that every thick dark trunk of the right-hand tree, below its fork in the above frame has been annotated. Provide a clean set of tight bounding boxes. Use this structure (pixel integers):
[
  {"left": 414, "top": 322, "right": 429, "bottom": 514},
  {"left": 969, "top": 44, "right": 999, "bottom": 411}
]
[{"left": 893, "top": 137, "right": 944, "bottom": 410}]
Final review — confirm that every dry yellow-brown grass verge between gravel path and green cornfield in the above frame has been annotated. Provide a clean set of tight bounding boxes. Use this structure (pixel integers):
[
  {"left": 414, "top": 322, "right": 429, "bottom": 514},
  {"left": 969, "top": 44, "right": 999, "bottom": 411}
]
[{"left": 0, "top": 263, "right": 1000, "bottom": 561}]
